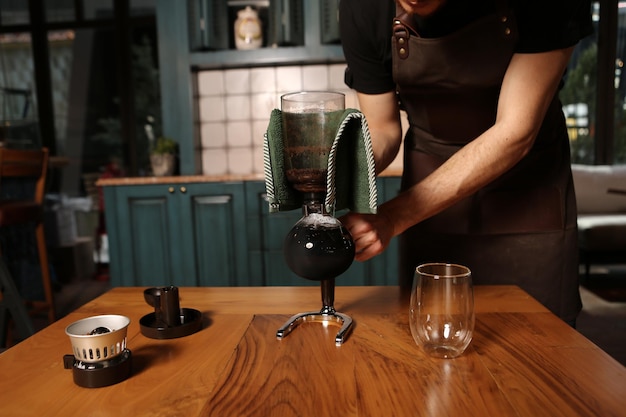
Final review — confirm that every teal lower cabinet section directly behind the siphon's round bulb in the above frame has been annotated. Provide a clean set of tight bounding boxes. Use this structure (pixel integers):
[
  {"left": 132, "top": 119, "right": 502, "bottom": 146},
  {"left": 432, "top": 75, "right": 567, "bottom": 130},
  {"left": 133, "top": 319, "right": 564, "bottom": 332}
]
[{"left": 246, "top": 177, "right": 400, "bottom": 285}]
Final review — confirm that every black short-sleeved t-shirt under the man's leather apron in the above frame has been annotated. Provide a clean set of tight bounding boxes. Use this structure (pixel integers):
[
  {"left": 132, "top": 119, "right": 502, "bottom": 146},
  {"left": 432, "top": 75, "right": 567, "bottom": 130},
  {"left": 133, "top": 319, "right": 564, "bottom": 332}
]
[{"left": 339, "top": 0, "right": 593, "bottom": 94}]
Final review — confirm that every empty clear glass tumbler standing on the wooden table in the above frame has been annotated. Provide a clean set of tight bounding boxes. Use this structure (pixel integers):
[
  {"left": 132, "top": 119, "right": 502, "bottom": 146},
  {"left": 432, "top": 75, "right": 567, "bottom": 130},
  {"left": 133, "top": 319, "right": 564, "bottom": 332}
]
[{"left": 409, "top": 263, "right": 474, "bottom": 358}]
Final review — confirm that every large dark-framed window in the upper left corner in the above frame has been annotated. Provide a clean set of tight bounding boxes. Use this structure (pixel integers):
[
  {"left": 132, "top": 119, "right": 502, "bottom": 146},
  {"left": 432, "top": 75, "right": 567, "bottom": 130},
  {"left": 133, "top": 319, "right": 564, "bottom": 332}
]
[{"left": 0, "top": 0, "right": 161, "bottom": 195}]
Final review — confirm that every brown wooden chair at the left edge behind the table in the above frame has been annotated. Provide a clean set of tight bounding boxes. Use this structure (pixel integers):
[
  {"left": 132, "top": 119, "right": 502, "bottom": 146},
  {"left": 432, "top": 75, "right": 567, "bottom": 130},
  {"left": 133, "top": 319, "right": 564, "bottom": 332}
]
[{"left": 0, "top": 147, "right": 56, "bottom": 334}]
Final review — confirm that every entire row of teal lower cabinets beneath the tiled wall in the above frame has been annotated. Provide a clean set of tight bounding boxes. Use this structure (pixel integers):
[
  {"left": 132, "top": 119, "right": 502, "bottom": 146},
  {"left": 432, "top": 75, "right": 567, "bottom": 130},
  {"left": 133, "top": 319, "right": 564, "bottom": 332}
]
[{"left": 103, "top": 176, "right": 400, "bottom": 286}]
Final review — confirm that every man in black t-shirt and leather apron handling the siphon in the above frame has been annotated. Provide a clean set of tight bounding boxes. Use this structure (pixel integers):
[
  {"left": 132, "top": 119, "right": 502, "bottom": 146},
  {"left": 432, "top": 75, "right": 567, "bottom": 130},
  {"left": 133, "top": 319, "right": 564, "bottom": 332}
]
[{"left": 340, "top": 0, "right": 592, "bottom": 323}]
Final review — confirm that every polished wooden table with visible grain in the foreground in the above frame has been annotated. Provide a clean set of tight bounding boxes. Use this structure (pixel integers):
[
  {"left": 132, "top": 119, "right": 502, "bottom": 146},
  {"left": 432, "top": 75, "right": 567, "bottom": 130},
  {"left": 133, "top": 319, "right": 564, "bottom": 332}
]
[{"left": 0, "top": 286, "right": 626, "bottom": 417}]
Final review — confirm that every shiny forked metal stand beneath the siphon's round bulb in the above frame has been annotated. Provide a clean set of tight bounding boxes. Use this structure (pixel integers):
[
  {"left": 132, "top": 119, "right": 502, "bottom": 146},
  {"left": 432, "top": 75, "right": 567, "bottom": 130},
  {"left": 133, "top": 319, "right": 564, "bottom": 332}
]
[{"left": 276, "top": 278, "right": 352, "bottom": 346}]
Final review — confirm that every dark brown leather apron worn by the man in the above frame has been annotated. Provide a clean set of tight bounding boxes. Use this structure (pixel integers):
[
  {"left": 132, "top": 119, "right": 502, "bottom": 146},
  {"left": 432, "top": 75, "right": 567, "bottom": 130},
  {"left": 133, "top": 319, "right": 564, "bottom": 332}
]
[{"left": 392, "top": 2, "right": 581, "bottom": 322}]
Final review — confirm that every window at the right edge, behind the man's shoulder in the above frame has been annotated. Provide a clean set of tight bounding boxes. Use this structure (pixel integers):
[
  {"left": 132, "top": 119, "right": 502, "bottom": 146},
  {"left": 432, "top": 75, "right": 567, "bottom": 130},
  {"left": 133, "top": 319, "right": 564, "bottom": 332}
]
[{"left": 560, "top": 1, "right": 626, "bottom": 164}]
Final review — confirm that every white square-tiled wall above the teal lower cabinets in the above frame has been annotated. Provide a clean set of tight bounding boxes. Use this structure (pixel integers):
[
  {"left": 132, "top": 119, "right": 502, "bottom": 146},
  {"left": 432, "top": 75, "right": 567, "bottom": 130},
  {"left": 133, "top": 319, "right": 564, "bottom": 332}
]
[{"left": 196, "top": 64, "right": 400, "bottom": 175}]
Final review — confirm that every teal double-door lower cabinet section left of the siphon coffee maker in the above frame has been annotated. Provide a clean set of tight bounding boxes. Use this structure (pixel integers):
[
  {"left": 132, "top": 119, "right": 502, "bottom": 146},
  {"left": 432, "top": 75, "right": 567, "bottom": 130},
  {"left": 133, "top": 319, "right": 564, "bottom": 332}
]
[{"left": 103, "top": 181, "right": 252, "bottom": 286}]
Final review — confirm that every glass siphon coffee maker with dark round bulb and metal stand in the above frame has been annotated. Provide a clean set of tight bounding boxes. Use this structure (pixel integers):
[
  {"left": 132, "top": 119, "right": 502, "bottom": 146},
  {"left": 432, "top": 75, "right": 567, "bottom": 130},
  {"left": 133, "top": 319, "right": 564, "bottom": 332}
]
[{"left": 276, "top": 91, "right": 354, "bottom": 345}]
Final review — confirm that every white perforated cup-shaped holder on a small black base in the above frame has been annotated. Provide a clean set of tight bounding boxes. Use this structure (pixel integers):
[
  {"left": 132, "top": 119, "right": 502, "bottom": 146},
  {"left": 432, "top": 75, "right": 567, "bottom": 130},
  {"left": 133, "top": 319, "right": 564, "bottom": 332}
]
[{"left": 65, "top": 314, "right": 130, "bottom": 363}]
